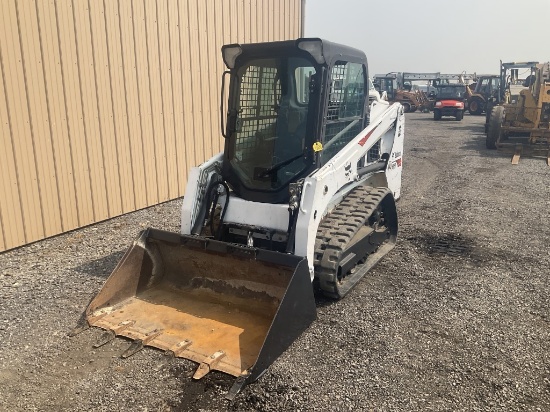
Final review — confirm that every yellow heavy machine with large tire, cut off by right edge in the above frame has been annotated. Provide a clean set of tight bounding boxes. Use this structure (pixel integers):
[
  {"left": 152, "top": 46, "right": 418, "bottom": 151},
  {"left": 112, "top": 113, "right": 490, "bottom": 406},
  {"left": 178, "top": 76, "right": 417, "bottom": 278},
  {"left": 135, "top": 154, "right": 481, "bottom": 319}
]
[{"left": 486, "top": 63, "right": 550, "bottom": 165}]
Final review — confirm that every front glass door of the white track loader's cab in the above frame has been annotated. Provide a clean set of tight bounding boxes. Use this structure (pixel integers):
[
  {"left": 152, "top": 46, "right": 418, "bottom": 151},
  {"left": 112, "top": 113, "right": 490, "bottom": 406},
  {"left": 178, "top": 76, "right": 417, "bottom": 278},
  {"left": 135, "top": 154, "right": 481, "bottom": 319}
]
[{"left": 229, "top": 57, "right": 316, "bottom": 190}]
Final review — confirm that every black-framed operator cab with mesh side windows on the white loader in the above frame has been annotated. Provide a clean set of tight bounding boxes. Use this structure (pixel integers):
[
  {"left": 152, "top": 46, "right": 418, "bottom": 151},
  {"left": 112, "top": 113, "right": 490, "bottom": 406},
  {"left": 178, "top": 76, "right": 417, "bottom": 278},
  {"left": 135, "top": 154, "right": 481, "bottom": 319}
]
[{"left": 222, "top": 39, "right": 368, "bottom": 203}]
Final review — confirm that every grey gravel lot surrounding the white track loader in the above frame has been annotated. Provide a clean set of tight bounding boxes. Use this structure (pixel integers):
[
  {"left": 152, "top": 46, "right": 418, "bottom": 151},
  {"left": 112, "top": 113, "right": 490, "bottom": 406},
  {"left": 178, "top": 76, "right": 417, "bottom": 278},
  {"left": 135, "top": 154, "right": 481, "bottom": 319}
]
[{"left": 0, "top": 113, "right": 550, "bottom": 411}]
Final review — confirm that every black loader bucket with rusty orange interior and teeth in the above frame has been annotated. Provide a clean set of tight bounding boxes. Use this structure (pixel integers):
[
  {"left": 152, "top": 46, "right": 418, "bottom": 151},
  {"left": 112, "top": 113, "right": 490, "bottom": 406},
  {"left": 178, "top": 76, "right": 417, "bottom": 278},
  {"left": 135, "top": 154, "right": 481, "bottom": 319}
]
[{"left": 85, "top": 229, "right": 316, "bottom": 391}]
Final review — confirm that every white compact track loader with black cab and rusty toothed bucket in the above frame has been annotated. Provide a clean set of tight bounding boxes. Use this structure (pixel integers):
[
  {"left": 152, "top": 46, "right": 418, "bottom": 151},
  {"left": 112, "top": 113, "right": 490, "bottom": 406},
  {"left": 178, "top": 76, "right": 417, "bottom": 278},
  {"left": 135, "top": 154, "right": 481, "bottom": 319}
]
[{"left": 74, "top": 38, "right": 404, "bottom": 398}]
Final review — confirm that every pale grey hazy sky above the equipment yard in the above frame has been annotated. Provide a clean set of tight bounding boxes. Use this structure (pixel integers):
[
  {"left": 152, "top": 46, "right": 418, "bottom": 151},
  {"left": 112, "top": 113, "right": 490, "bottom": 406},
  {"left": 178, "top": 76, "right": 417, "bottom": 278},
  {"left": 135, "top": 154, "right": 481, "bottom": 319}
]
[{"left": 305, "top": 0, "right": 550, "bottom": 77}]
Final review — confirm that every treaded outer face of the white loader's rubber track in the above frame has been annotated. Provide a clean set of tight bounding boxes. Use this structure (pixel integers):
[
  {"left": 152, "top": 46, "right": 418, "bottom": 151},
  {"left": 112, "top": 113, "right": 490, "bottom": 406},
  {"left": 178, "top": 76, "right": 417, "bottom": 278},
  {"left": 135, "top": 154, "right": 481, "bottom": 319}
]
[{"left": 314, "top": 186, "right": 391, "bottom": 298}]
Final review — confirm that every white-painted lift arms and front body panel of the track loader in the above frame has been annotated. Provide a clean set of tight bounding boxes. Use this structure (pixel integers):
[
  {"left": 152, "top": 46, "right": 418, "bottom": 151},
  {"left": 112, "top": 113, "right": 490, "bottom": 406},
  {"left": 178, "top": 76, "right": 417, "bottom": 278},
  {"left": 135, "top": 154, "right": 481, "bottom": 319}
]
[{"left": 181, "top": 101, "right": 405, "bottom": 280}]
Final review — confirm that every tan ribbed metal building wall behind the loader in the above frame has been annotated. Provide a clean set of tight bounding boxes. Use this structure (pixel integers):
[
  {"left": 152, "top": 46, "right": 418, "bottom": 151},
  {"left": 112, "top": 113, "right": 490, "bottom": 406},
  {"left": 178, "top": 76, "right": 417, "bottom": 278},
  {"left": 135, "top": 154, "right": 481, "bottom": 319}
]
[{"left": 0, "top": 0, "right": 303, "bottom": 251}]
